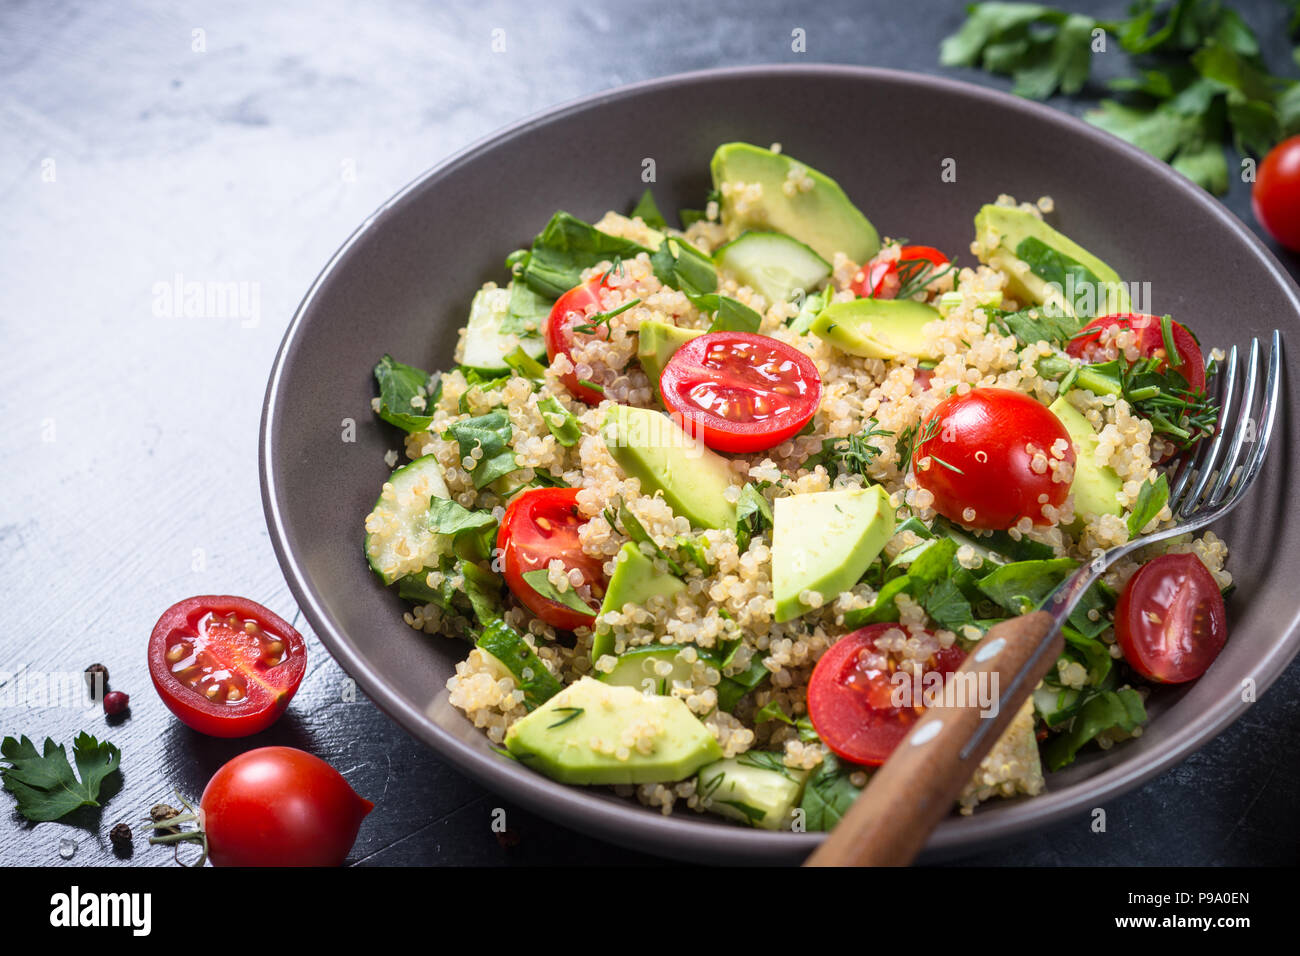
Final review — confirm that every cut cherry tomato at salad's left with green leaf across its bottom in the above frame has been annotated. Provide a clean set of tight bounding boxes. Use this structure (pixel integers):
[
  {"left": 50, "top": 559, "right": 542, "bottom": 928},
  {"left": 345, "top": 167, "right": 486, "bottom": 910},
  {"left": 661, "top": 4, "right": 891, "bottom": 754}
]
[{"left": 497, "top": 488, "right": 606, "bottom": 631}]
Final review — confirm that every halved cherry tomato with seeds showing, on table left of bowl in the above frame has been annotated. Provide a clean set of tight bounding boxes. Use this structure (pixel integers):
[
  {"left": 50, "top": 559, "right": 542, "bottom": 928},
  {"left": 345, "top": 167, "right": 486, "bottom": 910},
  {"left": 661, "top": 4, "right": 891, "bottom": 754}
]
[{"left": 150, "top": 594, "right": 307, "bottom": 737}]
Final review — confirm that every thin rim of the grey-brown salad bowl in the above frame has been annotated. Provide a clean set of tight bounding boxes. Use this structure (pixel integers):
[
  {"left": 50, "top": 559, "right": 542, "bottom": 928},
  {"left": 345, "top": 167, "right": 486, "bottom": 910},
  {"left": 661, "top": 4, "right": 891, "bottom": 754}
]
[{"left": 257, "top": 64, "right": 1300, "bottom": 862}]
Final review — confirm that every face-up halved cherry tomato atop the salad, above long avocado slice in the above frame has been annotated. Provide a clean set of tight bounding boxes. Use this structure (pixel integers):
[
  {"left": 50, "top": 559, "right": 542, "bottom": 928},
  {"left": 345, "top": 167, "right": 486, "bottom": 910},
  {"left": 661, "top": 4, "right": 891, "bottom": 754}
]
[{"left": 659, "top": 332, "right": 822, "bottom": 451}]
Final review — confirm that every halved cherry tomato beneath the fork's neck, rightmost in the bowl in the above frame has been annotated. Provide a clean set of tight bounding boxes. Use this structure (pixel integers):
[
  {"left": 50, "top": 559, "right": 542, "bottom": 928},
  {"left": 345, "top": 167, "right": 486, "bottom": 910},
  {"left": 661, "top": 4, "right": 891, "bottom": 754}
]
[{"left": 1115, "top": 554, "right": 1227, "bottom": 684}]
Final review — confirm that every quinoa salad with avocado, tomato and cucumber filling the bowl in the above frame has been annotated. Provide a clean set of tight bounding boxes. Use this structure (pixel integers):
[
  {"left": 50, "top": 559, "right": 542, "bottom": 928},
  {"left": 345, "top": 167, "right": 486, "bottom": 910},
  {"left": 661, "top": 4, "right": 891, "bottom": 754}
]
[{"left": 359, "top": 143, "right": 1231, "bottom": 830}]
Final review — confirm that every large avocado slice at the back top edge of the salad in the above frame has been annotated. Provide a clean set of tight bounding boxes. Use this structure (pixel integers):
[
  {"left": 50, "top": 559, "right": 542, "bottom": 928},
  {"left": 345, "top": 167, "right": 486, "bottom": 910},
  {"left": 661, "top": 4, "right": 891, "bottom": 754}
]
[{"left": 709, "top": 143, "right": 880, "bottom": 263}]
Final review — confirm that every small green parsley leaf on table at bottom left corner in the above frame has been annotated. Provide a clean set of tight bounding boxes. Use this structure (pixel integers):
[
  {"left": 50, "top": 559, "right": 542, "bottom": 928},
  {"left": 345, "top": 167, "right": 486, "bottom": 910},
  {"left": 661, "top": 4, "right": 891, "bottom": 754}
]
[{"left": 0, "top": 732, "right": 122, "bottom": 823}]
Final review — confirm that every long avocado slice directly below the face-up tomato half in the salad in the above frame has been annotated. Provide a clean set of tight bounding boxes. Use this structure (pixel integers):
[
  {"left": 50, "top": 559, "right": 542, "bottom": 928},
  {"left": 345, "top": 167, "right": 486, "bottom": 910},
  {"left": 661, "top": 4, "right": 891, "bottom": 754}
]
[{"left": 601, "top": 405, "right": 736, "bottom": 528}]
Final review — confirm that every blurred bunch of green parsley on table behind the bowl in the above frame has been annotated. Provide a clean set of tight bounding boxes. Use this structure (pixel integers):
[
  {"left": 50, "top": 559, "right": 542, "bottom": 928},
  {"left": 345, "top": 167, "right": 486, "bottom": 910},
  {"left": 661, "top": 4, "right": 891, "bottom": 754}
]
[{"left": 940, "top": 0, "right": 1300, "bottom": 193}]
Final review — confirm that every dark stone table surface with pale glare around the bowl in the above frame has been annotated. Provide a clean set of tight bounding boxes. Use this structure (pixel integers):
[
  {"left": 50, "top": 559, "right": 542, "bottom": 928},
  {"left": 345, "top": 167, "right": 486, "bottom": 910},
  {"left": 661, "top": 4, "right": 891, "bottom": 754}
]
[{"left": 0, "top": 0, "right": 1300, "bottom": 865}]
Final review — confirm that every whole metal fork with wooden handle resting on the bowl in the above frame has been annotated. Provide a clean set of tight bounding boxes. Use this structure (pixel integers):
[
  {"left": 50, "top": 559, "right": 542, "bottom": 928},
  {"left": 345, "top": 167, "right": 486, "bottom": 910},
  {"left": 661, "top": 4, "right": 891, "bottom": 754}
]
[{"left": 806, "top": 330, "right": 1282, "bottom": 866}]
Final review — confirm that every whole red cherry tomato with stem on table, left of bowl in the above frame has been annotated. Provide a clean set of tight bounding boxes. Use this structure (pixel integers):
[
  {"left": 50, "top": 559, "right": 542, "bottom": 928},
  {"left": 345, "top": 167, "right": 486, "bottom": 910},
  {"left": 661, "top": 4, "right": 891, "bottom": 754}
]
[{"left": 199, "top": 747, "right": 374, "bottom": 866}]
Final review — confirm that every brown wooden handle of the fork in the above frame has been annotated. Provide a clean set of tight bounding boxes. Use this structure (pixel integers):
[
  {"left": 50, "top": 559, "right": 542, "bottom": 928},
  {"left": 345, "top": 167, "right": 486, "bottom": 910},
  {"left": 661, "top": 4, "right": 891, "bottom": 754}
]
[{"left": 805, "top": 611, "right": 1062, "bottom": 866}]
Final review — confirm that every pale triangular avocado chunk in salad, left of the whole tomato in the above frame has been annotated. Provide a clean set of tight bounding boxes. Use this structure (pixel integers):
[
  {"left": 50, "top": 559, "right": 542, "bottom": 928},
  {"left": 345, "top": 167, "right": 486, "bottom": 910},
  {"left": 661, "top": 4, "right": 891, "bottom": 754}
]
[{"left": 772, "top": 485, "right": 894, "bottom": 622}]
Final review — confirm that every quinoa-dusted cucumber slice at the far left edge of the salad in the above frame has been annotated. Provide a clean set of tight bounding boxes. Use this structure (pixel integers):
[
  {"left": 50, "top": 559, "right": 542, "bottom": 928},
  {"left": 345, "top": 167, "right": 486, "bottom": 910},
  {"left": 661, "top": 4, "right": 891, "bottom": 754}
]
[{"left": 365, "top": 455, "right": 451, "bottom": 584}]
